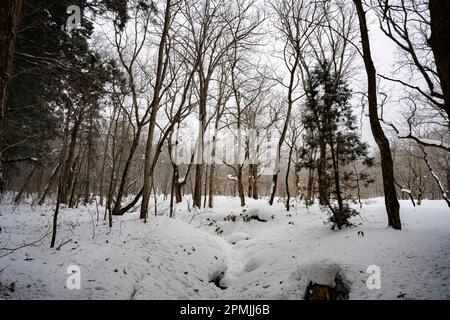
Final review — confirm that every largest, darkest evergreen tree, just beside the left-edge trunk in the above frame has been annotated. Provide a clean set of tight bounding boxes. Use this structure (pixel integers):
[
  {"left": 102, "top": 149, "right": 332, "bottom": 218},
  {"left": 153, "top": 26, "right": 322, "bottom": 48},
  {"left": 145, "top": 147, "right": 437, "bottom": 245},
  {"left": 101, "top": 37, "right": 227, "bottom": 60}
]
[{"left": 4, "top": 0, "right": 93, "bottom": 173}]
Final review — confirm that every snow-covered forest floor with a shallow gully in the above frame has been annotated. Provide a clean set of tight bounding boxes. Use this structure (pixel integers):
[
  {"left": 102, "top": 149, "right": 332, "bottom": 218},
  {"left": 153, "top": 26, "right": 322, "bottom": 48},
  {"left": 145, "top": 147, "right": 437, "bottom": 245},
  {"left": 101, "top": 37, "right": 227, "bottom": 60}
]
[{"left": 0, "top": 196, "right": 450, "bottom": 299}]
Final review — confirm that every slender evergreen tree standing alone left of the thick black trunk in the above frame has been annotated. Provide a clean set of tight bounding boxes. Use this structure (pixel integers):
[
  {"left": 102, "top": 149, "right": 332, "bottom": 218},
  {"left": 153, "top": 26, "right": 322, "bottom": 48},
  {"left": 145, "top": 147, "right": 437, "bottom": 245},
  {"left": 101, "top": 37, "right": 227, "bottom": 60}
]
[{"left": 302, "top": 61, "right": 369, "bottom": 229}]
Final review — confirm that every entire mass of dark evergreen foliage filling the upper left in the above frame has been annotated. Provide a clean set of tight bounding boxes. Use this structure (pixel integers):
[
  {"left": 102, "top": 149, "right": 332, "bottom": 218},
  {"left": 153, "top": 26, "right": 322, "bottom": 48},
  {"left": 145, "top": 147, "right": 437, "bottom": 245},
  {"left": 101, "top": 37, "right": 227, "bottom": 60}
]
[{"left": 4, "top": 0, "right": 123, "bottom": 182}]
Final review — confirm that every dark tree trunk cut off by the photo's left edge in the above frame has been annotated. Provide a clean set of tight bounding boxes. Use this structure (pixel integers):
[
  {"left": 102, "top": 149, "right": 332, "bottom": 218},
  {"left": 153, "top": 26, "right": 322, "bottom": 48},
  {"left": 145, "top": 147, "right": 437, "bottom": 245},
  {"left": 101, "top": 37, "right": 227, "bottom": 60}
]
[{"left": 0, "top": 0, "right": 23, "bottom": 194}]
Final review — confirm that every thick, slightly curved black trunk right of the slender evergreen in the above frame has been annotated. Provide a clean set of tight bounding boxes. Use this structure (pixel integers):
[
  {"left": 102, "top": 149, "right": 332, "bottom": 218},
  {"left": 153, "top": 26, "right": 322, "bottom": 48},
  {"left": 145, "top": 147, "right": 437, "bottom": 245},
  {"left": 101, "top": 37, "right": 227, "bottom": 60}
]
[{"left": 353, "top": 0, "right": 402, "bottom": 230}]
